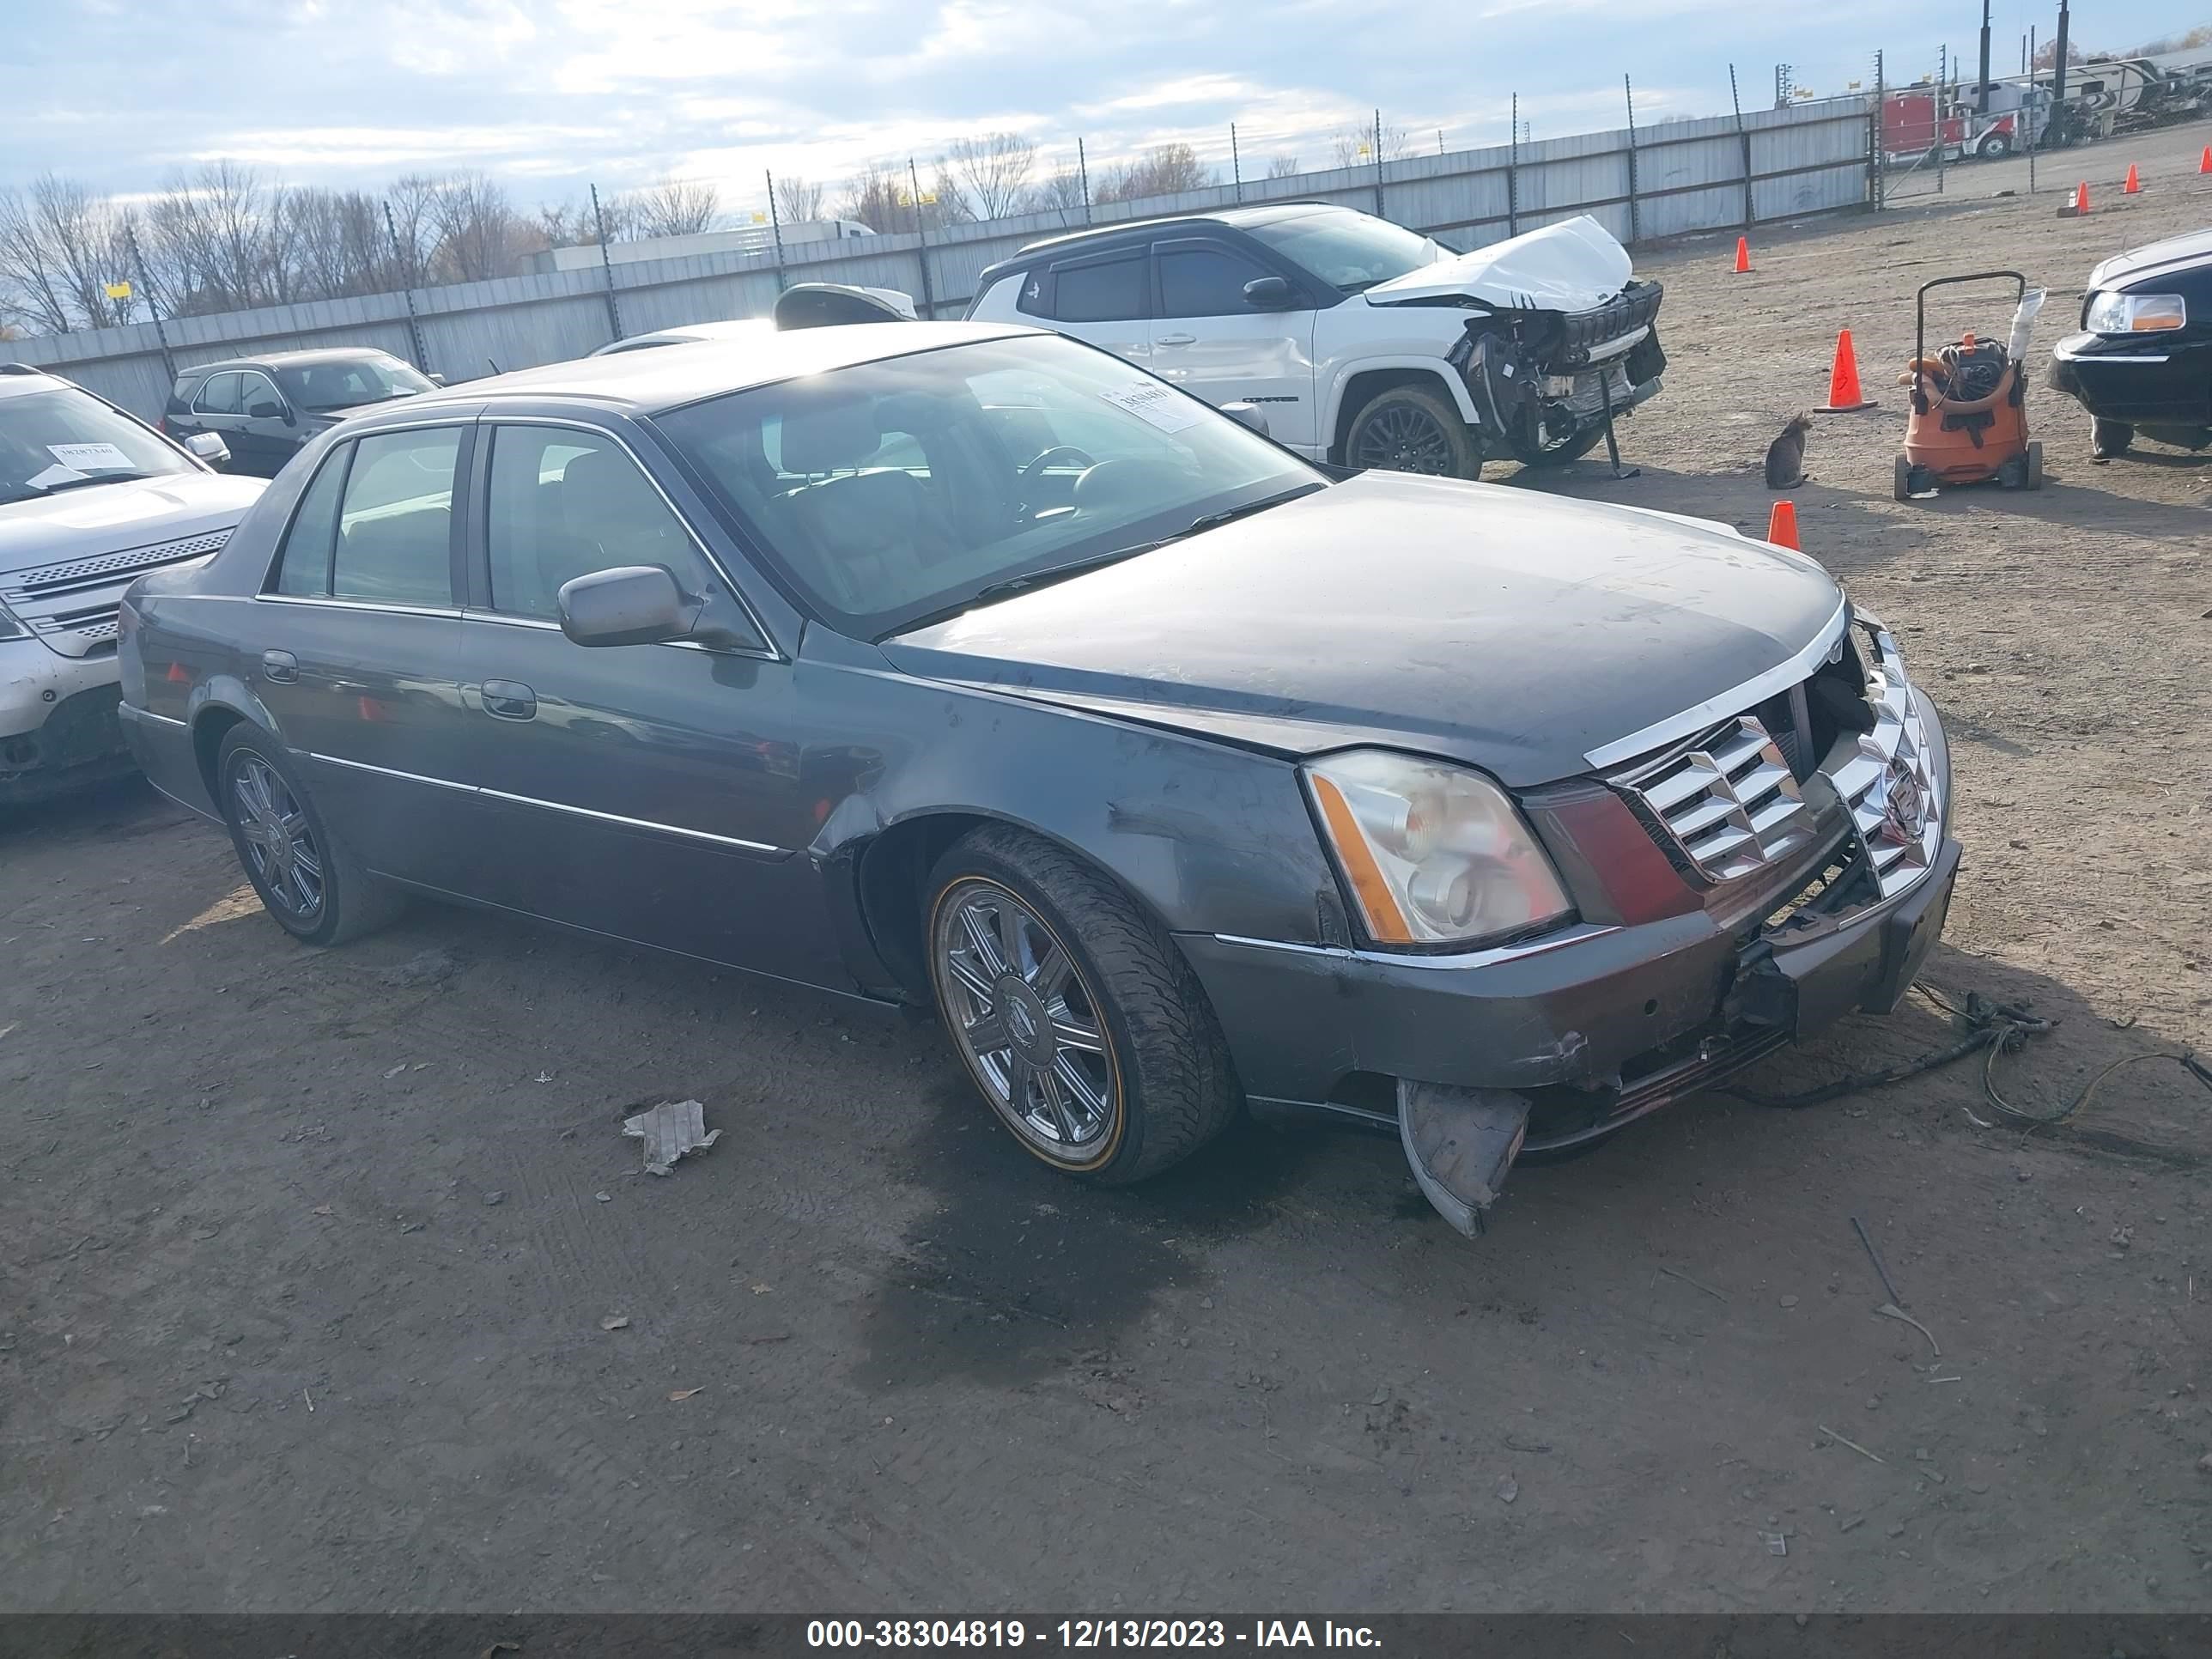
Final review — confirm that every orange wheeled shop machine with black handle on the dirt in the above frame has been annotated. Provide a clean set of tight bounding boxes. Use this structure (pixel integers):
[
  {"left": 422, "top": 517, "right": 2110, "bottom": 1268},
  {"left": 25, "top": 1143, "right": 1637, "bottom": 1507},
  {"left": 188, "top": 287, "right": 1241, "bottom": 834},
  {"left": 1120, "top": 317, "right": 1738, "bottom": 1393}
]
[{"left": 1896, "top": 270, "right": 2044, "bottom": 502}]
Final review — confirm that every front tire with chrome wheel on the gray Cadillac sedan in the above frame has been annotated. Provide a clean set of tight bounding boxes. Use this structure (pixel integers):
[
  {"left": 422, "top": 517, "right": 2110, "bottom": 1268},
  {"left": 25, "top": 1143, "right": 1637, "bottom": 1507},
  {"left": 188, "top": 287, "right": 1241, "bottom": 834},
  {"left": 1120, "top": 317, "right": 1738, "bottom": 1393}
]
[{"left": 925, "top": 825, "right": 1243, "bottom": 1186}]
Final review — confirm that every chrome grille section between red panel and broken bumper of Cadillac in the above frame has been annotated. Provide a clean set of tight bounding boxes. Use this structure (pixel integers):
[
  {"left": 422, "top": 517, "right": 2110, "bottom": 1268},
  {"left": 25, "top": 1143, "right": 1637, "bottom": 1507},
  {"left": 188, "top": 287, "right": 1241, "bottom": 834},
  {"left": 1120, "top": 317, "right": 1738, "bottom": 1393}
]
[{"left": 1620, "top": 714, "right": 1814, "bottom": 880}]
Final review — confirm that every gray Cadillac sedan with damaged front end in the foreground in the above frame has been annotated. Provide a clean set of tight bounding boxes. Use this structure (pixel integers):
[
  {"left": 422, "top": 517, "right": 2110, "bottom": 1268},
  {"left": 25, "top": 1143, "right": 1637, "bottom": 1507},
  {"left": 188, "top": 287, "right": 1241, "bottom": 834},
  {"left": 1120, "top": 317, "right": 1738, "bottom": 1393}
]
[{"left": 122, "top": 323, "right": 1958, "bottom": 1230}]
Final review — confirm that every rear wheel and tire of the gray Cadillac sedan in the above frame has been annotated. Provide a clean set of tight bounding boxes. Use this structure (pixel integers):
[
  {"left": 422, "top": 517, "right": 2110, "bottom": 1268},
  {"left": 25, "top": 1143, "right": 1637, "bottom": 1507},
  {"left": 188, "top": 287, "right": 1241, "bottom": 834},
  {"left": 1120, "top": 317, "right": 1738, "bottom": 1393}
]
[{"left": 215, "top": 723, "right": 400, "bottom": 945}]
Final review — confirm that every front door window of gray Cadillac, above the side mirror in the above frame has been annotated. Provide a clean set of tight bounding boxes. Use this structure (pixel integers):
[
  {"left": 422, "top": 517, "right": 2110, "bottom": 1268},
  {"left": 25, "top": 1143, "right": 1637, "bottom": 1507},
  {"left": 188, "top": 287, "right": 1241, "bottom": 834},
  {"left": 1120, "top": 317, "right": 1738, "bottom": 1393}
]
[{"left": 484, "top": 425, "right": 717, "bottom": 622}]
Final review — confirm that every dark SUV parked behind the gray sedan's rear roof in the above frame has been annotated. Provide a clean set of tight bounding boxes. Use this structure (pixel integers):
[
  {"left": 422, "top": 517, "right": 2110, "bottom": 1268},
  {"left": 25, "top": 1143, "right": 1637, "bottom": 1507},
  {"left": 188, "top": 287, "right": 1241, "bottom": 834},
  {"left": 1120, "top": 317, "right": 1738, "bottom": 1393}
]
[{"left": 161, "top": 345, "right": 442, "bottom": 477}]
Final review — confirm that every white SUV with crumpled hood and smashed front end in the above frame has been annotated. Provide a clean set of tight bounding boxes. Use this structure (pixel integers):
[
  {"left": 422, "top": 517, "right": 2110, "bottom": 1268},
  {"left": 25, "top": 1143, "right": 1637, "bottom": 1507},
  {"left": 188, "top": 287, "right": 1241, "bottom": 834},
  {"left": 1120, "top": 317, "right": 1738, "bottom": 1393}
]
[{"left": 969, "top": 201, "right": 1666, "bottom": 477}]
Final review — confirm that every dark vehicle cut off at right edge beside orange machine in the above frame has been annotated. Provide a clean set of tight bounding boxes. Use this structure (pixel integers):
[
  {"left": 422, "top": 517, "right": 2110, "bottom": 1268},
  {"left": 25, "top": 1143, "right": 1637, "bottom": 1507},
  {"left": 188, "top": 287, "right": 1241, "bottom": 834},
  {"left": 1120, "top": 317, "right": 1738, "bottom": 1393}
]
[{"left": 2051, "top": 230, "right": 2212, "bottom": 460}]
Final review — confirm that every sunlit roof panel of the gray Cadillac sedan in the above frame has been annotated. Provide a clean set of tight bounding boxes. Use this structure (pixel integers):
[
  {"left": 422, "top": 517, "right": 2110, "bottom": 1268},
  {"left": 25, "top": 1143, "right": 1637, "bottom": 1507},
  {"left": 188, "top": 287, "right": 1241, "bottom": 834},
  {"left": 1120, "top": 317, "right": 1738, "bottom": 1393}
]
[{"left": 404, "top": 323, "right": 1046, "bottom": 420}]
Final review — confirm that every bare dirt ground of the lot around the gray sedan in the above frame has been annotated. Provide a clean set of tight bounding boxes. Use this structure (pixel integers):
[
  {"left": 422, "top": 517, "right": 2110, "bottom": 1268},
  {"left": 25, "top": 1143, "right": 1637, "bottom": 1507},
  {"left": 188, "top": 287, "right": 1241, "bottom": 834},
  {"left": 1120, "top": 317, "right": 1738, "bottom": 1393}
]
[{"left": 0, "top": 128, "right": 2212, "bottom": 1613}]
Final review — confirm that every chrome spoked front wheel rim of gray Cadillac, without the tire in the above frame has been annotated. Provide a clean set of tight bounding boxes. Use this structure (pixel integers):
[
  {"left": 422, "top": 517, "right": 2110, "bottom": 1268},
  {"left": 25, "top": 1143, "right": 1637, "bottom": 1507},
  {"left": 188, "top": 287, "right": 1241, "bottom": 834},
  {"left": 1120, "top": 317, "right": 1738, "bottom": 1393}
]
[{"left": 931, "top": 878, "right": 1121, "bottom": 1168}]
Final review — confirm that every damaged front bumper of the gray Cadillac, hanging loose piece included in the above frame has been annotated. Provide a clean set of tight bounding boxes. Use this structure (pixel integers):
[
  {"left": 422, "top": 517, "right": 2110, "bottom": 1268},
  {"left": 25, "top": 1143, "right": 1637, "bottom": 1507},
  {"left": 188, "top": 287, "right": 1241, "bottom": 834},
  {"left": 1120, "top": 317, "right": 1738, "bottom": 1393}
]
[{"left": 1179, "top": 663, "right": 1960, "bottom": 1230}]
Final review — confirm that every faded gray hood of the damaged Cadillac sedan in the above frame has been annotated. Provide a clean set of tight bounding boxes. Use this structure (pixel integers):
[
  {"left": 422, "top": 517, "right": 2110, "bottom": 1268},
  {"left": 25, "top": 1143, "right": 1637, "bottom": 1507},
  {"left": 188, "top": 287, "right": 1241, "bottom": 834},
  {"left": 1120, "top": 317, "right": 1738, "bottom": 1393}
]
[{"left": 883, "top": 473, "right": 1843, "bottom": 787}]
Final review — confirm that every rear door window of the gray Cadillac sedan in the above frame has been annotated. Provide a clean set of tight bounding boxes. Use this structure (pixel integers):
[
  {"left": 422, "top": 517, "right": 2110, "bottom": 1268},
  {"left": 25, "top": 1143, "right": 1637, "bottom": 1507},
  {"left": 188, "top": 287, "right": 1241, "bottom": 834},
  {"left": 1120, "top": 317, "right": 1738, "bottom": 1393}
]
[{"left": 330, "top": 427, "right": 462, "bottom": 606}]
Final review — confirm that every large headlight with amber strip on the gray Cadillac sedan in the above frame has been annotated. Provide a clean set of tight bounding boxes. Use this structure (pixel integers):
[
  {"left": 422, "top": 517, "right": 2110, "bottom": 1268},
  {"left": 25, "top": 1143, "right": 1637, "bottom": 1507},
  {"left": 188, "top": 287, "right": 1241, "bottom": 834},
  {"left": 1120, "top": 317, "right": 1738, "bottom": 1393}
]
[{"left": 1305, "top": 750, "right": 1575, "bottom": 945}]
